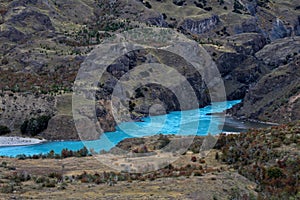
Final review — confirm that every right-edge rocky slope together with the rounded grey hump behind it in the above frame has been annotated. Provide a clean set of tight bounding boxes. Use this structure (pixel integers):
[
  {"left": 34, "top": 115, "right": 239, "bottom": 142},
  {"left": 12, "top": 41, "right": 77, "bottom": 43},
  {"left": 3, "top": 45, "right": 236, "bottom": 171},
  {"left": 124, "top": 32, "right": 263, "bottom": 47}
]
[{"left": 231, "top": 37, "right": 300, "bottom": 123}]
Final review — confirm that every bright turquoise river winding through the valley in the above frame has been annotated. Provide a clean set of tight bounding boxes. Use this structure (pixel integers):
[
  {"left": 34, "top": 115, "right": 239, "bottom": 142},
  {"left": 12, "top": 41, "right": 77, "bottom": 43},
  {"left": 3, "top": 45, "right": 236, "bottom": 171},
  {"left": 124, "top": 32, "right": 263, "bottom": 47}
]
[{"left": 0, "top": 100, "right": 268, "bottom": 157}]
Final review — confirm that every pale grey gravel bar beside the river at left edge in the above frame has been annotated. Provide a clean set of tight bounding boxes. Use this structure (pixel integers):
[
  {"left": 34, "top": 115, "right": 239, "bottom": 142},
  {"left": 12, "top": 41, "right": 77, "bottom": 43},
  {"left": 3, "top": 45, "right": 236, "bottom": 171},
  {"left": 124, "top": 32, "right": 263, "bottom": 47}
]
[{"left": 0, "top": 136, "right": 46, "bottom": 147}]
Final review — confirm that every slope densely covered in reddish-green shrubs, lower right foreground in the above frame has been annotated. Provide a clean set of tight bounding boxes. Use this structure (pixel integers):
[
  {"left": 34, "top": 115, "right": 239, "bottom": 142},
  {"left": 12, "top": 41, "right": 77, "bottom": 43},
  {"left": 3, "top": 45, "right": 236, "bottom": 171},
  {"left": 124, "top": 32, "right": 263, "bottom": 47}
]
[{"left": 216, "top": 122, "right": 300, "bottom": 199}]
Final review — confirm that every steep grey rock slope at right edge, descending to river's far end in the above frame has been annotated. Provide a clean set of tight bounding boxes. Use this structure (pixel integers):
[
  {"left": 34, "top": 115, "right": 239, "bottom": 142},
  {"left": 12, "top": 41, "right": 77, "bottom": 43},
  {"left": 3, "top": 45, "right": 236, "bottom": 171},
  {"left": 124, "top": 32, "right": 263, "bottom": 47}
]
[{"left": 231, "top": 52, "right": 300, "bottom": 123}]
